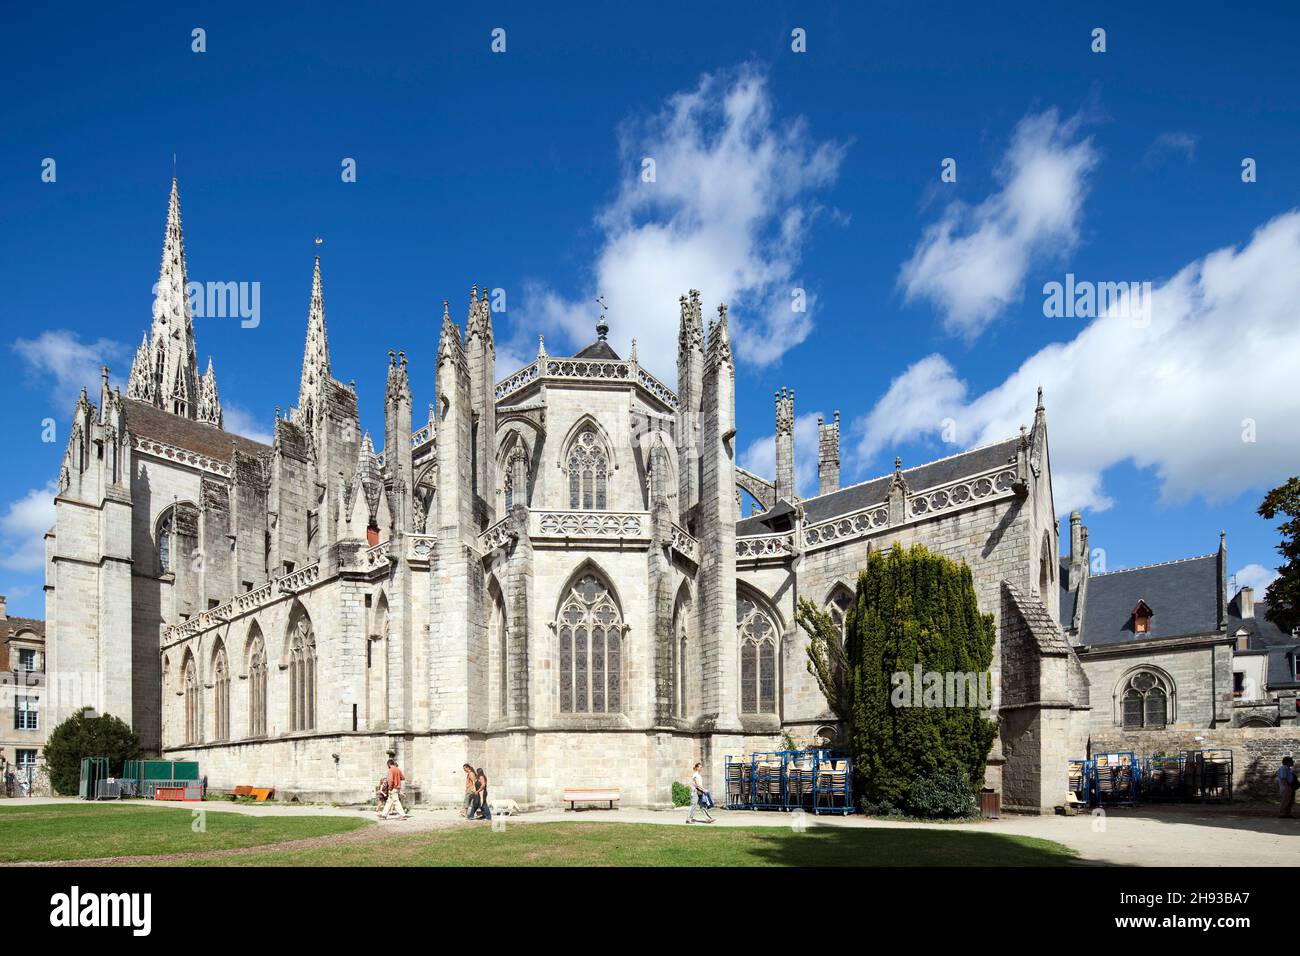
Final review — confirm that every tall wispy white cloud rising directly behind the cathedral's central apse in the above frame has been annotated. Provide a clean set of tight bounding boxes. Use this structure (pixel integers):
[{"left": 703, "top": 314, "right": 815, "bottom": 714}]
[{"left": 506, "top": 66, "right": 845, "bottom": 381}]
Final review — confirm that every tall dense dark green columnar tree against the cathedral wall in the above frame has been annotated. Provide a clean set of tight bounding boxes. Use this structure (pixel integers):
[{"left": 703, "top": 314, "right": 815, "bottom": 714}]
[{"left": 797, "top": 545, "right": 997, "bottom": 806}]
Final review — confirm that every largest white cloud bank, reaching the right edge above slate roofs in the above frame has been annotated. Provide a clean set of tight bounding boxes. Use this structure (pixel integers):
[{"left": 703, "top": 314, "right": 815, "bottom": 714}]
[{"left": 853, "top": 211, "right": 1300, "bottom": 511}]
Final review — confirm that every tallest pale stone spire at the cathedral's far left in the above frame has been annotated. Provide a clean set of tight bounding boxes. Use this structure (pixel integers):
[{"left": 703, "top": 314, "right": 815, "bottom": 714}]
[{"left": 148, "top": 177, "right": 199, "bottom": 419}]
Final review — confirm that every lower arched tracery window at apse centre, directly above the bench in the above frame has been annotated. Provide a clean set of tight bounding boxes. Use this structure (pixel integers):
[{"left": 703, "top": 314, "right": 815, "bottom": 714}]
[{"left": 555, "top": 572, "right": 623, "bottom": 714}]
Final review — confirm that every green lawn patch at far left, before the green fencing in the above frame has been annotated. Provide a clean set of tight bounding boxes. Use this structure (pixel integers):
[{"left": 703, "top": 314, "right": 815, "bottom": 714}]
[{"left": 0, "top": 801, "right": 369, "bottom": 864}]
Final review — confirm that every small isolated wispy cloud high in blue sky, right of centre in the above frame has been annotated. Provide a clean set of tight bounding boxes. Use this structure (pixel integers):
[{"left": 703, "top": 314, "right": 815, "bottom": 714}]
[{"left": 898, "top": 109, "right": 1097, "bottom": 339}]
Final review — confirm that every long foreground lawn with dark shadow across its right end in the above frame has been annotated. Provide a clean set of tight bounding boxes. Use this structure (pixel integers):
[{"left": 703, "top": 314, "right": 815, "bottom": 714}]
[{"left": 181, "top": 823, "right": 1074, "bottom": 866}]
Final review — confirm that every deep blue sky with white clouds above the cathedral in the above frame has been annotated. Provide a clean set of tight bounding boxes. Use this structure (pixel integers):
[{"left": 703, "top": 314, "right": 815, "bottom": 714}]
[{"left": 0, "top": 3, "right": 1300, "bottom": 615}]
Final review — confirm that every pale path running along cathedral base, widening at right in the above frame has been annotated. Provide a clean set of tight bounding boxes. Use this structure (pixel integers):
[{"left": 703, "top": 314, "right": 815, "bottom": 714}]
[{"left": 10, "top": 797, "right": 1300, "bottom": 866}]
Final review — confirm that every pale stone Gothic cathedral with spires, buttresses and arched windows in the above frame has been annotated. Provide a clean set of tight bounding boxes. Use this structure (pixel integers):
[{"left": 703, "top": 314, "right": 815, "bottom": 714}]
[{"left": 47, "top": 183, "right": 1087, "bottom": 810}]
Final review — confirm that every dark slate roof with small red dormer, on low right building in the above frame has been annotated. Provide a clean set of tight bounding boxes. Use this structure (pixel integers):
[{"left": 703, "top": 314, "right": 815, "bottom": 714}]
[{"left": 1062, "top": 553, "right": 1222, "bottom": 646}]
